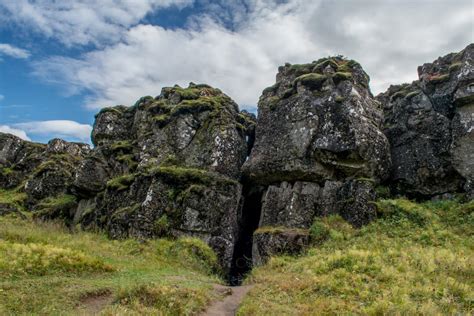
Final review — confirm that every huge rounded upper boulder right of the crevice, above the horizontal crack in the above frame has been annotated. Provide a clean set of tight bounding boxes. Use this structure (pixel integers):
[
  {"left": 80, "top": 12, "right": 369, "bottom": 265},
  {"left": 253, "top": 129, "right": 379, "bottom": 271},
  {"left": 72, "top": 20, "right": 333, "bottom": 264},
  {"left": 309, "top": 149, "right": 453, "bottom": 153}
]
[{"left": 243, "top": 57, "right": 390, "bottom": 184}]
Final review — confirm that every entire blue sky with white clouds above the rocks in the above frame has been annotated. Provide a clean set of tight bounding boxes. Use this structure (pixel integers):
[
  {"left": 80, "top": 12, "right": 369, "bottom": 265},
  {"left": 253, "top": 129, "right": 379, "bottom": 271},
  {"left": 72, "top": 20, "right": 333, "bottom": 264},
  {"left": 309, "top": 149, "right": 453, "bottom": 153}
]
[{"left": 0, "top": 0, "right": 474, "bottom": 143}]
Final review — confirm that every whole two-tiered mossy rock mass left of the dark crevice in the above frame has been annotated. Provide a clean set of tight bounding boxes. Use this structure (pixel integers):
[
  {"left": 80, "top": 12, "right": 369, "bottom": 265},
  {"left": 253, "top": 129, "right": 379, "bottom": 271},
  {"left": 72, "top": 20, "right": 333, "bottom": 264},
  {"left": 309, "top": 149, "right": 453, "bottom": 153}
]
[{"left": 73, "top": 84, "right": 255, "bottom": 271}]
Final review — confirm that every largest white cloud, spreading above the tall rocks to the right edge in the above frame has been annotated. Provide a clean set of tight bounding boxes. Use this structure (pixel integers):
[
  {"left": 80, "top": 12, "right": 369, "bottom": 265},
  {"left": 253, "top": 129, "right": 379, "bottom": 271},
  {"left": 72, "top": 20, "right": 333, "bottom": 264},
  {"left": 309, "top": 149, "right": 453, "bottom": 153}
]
[{"left": 28, "top": 0, "right": 474, "bottom": 108}]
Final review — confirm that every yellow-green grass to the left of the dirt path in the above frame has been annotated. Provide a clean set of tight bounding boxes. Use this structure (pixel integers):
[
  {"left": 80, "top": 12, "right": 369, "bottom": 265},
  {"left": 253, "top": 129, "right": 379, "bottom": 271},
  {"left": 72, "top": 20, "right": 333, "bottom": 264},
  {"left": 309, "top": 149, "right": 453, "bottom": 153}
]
[{"left": 0, "top": 217, "right": 221, "bottom": 315}]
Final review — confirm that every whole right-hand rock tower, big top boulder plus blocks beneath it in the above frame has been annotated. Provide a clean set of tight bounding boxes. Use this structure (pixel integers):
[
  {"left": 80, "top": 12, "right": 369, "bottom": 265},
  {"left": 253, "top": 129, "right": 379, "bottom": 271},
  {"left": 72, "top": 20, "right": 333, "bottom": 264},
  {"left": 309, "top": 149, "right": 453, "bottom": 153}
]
[{"left": 243, "top": 57, "right": 390, "bottom": 264}]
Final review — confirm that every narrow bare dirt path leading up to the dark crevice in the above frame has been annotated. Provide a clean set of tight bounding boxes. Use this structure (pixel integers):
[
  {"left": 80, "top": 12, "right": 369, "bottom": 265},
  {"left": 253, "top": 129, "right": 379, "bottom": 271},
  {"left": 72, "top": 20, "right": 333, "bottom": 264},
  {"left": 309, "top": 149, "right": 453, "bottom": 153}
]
[{"left": 202, "top": 285, "right": 253, "bottom": 316}]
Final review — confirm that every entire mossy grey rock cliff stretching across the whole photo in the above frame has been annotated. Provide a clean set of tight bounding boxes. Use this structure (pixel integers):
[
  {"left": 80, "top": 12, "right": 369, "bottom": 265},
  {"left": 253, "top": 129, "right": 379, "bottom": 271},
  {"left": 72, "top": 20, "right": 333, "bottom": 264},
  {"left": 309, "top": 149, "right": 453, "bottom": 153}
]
[{"left": 0, "top": 44, "right": 474, "bottom": 282}]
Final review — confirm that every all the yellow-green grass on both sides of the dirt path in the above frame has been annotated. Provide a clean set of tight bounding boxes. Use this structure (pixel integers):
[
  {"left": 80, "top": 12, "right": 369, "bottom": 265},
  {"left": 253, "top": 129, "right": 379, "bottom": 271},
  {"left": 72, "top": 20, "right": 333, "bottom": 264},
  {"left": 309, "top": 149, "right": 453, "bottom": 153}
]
[{"left": 0, "top": 199, "right": 474, "bottom": 315}]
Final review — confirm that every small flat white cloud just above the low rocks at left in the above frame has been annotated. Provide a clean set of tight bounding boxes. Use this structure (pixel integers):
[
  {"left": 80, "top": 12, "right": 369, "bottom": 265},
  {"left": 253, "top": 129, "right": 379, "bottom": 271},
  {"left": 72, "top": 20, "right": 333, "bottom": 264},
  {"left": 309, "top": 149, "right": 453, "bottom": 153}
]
[{"left": 13, "top": 120, "right": 92, "bottom": 142}]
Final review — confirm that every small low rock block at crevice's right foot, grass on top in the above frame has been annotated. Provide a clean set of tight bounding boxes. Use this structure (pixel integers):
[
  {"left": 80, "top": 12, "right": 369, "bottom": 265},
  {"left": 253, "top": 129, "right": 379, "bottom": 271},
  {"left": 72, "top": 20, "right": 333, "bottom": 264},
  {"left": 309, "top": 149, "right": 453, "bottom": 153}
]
[{"left": 252, "top": 227, "right": 309, "bottom": 266}]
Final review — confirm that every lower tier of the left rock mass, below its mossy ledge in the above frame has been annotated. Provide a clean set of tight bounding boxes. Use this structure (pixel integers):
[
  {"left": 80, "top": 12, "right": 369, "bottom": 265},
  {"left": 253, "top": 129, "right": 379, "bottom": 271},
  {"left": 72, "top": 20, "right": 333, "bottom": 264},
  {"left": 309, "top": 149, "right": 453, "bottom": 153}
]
[{"left": 91, "top": 167, "right": 241, "bottom": 271}]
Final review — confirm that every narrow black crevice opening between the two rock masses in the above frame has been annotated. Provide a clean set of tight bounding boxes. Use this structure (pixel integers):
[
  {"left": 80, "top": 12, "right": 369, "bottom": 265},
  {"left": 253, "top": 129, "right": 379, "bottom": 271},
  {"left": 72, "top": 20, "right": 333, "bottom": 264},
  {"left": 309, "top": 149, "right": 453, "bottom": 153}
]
[{"left": 227, "top": 184, "right": 264, "bottom": 286}]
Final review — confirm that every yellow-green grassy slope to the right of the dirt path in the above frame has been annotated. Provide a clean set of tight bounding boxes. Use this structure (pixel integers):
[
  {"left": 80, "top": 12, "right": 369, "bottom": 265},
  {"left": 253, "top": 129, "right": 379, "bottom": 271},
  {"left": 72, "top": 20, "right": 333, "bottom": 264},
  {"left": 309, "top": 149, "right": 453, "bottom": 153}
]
[{"left": 239, "top": 199, "right": 474, "bottom": 315}]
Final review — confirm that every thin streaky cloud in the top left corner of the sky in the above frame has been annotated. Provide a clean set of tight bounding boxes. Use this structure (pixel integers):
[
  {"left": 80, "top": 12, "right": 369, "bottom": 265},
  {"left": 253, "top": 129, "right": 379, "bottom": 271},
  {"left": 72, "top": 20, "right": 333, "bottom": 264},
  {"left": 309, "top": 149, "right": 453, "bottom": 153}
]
[{"left": 0, "top": 0, "right": 192, "bottom": 46}]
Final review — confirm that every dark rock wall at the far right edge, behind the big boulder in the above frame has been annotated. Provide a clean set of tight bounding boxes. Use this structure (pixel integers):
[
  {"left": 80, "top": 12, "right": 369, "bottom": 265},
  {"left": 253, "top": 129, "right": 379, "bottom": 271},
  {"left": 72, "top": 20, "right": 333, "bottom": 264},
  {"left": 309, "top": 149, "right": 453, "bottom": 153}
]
[{"left": 377, "top": 44, "right": 474, "bottom": 197}]
